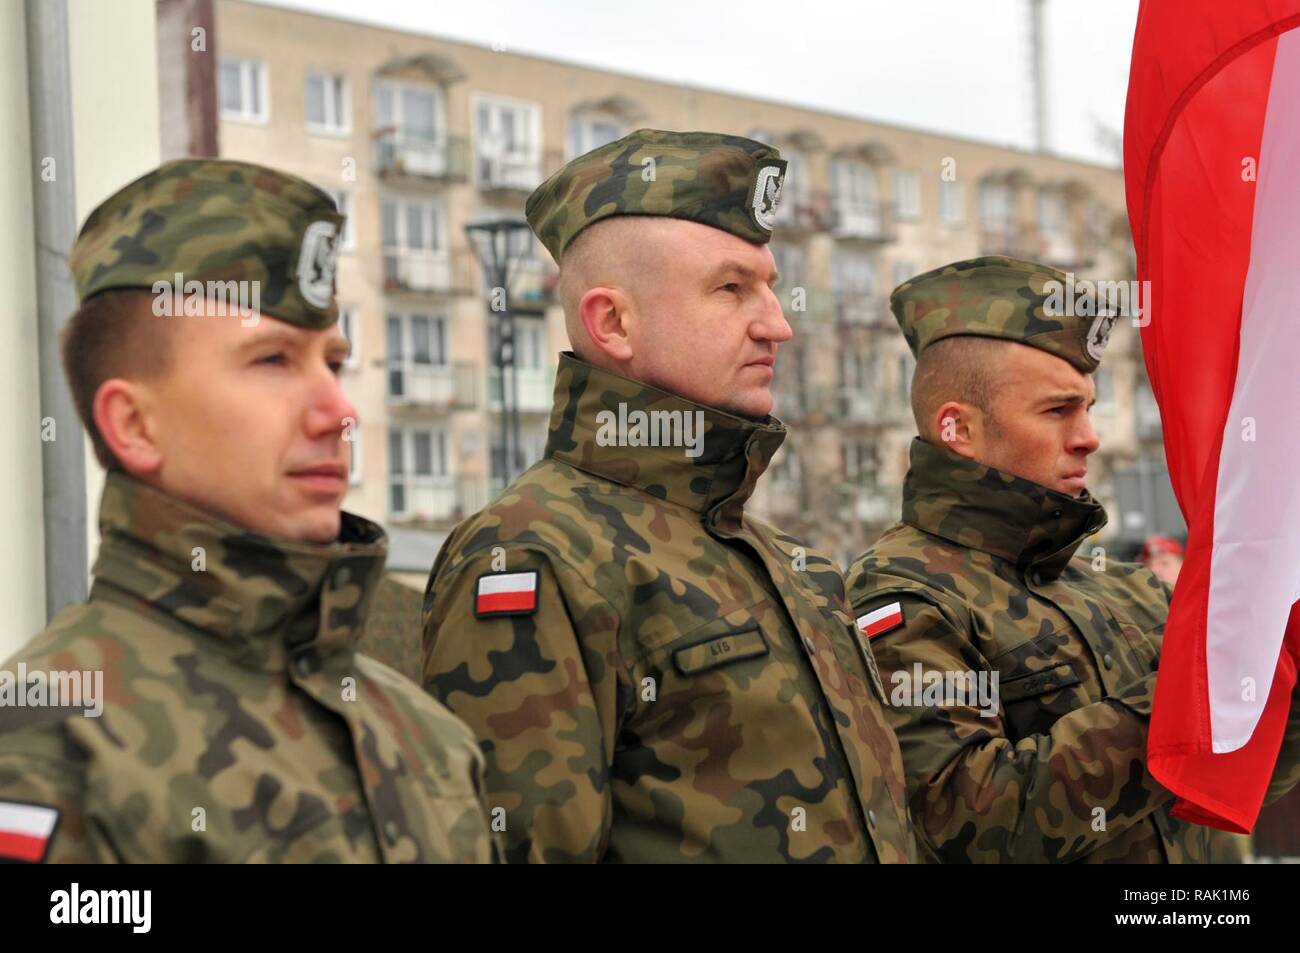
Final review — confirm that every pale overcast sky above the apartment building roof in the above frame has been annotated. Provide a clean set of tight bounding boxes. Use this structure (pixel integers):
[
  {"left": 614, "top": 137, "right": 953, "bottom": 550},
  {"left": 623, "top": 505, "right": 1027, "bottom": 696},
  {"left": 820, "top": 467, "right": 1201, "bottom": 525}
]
[{"left": 257, "top": 0, "right": 1138, "bottom": 164}]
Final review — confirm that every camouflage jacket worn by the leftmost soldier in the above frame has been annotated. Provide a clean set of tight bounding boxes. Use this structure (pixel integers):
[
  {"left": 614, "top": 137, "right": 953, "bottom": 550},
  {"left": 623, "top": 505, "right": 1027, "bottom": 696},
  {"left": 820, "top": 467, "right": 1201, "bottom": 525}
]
[{"left": 0, "top": 473, "right": 494, "bottom": 862}]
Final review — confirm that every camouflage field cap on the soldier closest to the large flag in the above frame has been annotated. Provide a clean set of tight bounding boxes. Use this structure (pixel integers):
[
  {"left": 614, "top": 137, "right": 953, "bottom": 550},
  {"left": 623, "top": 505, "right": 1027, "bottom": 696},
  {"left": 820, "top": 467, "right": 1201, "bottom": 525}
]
[{"left": 889, "top": 255, "right": 1117, "bottom": 374}]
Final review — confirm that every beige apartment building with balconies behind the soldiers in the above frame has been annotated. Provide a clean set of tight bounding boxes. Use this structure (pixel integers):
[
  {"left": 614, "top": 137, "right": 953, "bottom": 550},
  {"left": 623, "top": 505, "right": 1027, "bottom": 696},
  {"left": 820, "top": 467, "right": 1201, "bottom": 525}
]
[{"left": 205, "top": 0, "right": 1177, "bottom": 572}]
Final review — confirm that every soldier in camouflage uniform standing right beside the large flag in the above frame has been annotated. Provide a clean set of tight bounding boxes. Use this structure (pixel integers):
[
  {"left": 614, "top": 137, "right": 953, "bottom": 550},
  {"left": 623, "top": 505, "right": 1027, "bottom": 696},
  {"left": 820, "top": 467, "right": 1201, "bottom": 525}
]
[{"left": 849, "top": 257, "right": 1300, "bottom": 863}]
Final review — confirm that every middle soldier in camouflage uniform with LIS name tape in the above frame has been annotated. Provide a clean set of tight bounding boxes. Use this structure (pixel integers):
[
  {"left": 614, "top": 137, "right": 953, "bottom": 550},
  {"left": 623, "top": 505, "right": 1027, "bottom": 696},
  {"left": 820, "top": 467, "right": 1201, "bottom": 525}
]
[{"left": 424, "top": 130, "right": 915, "bottom": 862}]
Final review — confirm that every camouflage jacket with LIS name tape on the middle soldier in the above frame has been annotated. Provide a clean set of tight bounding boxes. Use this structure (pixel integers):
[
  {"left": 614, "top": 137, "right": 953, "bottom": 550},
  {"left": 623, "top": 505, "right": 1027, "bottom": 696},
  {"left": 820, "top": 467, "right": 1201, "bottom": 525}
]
[{"left": 424, "top": 355, "right": 915, "bottom": 862}]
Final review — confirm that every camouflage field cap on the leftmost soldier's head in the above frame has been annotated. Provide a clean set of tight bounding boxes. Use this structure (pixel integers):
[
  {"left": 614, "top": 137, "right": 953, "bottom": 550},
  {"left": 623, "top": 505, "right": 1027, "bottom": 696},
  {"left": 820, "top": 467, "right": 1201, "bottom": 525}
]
[{"left": 68, "top": 159, "right": 343, "bottom": 329}]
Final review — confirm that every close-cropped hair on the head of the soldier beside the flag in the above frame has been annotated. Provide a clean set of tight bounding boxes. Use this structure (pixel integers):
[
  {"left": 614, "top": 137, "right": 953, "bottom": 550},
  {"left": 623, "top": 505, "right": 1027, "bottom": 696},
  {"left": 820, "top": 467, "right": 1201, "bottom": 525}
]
[{"left": 911, "top": 334, "right": 1017, "bottom": 443}]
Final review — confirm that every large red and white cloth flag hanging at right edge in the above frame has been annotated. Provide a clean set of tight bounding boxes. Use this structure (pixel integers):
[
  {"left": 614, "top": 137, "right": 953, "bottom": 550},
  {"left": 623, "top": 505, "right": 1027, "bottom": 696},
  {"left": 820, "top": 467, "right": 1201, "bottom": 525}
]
[{"left": 1125, "top": 0, "right": 1300, "bottom": 831}]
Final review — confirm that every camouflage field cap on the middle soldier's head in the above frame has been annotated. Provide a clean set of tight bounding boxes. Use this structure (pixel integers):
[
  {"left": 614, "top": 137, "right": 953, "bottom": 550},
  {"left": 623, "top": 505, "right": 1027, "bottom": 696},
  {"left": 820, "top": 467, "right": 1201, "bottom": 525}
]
[{"left": 527, "top": 129, "right": 785, "bottom": 263}]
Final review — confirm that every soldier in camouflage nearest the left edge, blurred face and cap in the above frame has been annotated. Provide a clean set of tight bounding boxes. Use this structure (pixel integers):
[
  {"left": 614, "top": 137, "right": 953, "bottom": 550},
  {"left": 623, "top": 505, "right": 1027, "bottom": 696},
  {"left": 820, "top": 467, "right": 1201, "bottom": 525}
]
[{"left": 0, "top": 159, "right": 495, "bottom": 863}]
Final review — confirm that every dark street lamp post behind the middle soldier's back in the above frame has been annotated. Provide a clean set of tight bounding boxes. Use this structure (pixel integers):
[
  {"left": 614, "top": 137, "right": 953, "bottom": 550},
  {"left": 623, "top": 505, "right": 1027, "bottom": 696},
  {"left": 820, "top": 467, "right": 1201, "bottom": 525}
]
[{"left": 465, "top": 218, "right": 530, "bottom": 486}]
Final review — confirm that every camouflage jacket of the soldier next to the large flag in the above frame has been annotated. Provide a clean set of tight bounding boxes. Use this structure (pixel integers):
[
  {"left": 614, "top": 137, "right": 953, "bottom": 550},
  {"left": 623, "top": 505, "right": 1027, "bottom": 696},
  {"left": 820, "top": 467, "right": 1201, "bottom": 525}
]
[{"left": 849, "top": 439, "right": 1300, "bottom": 863}]
